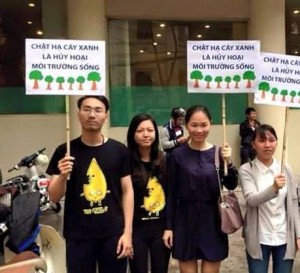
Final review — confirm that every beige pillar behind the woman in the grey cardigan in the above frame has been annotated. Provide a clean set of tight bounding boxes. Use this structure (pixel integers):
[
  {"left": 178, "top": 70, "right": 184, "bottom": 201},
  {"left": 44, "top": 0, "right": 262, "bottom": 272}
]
[{"left": 248, "top": 0, "right": 285, "bottom": 159}]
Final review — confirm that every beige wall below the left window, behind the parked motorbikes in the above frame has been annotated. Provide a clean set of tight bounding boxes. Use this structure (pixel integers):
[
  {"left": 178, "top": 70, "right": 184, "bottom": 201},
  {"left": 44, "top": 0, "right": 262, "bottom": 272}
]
[{"left": 0, "top": 115, "right": 65, "bottom": 179}]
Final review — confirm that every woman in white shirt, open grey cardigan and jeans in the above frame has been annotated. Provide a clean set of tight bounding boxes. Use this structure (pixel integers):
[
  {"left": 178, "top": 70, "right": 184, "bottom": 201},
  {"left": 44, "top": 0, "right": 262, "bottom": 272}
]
[{"left": 239, "top": 124, "right": 300, "bottom": 273}]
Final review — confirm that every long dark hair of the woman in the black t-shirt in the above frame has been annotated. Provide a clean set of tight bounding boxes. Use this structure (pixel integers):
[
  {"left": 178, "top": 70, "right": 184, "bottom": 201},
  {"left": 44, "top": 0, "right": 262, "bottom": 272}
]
[{"left": 127, "top": 113, "right": 165, "bottom": 184}]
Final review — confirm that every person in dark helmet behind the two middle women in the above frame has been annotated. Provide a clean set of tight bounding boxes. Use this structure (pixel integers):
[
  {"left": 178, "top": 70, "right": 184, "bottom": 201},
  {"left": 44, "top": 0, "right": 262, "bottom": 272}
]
[{"left": 160, "top": 107, "right": 188, "bottom": 152}]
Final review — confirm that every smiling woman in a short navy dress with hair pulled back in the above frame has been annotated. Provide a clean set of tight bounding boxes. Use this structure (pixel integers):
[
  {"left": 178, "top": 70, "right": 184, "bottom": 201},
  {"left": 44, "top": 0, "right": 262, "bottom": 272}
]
[{"left": 164, "top": 105, "right": 238, "bottom": 273}]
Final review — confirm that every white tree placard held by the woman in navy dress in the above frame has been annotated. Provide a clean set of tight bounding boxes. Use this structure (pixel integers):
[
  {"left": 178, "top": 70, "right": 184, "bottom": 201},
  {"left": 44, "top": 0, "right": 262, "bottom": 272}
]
[{"left": 187, "top": 41, "right": 260, "bottom": 93}]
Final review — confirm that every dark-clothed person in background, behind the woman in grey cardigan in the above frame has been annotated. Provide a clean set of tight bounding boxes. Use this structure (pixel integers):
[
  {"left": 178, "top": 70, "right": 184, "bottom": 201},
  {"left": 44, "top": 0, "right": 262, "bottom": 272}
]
[{"left": 240, "top": 107, "right": 260, "bottom": 165}]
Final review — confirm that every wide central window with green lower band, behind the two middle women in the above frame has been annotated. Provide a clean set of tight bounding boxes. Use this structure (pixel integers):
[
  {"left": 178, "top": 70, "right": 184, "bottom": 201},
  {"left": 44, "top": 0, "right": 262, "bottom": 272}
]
[{"left": 108, "top": 19, "right": 248, "bottom": 126}]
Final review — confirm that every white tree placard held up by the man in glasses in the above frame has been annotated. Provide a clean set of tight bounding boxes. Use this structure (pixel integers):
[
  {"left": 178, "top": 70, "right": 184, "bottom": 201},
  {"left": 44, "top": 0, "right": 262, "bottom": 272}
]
[{"left": 26, "top": 39, "right": 106, "bottom": 95}]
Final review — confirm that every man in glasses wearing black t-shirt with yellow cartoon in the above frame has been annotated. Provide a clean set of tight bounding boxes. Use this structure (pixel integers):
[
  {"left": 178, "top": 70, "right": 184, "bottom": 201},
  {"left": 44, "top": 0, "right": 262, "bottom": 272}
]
[{"left": 47, "top": 96, "right": 134, "bottom": 273}]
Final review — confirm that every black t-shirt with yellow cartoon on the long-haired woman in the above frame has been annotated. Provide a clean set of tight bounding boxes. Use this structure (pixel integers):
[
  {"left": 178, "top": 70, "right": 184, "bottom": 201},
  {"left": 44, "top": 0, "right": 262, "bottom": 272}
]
[{"left": 133, "top": 162, "right": 166, "bottom": 223}]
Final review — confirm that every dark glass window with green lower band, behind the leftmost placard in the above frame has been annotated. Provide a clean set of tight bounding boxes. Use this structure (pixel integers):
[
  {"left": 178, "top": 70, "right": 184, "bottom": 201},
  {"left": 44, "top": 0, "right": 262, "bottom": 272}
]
[{"left": 0, "top": 0, "right": 65, "bottom": 114}]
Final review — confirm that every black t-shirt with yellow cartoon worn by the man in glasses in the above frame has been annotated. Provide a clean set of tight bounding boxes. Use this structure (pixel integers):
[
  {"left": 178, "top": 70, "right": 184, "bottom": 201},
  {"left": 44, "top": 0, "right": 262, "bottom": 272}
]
[{"left": 47, "top": 138, "right": 130, "bottom": 239}]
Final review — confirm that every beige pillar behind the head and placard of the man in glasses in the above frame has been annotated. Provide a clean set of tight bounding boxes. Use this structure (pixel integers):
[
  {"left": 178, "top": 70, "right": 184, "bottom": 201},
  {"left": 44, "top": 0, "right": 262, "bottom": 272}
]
[{"left": 67, "top": 0, "right": 108, "bottom": 138}]
